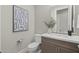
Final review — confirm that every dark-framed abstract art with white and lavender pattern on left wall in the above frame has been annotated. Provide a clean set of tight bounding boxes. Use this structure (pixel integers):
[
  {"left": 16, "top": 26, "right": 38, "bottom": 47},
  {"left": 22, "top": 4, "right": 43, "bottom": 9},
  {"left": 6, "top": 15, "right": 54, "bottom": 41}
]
[{"left": 13, "top": 5, "right": 29, "bottom": 32}]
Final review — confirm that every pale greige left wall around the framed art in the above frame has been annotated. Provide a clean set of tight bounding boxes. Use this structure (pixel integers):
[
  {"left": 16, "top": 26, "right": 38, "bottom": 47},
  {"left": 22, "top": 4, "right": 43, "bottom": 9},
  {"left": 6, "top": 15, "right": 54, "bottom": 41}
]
[{"left": 1, "top": 5, "right": 34, "bottom": 52}]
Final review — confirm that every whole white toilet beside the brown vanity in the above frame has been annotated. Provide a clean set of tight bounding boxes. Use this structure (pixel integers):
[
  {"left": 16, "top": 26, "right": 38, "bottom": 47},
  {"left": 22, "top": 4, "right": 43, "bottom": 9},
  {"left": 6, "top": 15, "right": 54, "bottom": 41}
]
[{"left": 28, "top": 34, "right": 41, "bottom": 53}]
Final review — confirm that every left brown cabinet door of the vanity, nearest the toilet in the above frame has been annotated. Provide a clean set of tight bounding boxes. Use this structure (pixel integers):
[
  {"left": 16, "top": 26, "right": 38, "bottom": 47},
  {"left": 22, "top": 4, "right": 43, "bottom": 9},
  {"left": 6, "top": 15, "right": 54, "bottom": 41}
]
[{"left": 42, "top": 42, "right": 58, "bottom": 53}]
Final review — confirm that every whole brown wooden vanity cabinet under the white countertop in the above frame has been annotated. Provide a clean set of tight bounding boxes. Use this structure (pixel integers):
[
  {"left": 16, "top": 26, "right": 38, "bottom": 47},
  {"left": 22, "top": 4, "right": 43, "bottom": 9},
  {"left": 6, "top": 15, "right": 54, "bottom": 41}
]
[{"left": 41, "top": 37, "right": 79, "bottom": 53}]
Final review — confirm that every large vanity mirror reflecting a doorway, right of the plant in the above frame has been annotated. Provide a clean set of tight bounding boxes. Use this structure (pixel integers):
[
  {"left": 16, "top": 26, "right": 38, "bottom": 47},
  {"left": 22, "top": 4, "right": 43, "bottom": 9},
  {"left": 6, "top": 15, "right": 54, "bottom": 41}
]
[{"left": 51, "top": 5, "right": 72, "bottom": 33}]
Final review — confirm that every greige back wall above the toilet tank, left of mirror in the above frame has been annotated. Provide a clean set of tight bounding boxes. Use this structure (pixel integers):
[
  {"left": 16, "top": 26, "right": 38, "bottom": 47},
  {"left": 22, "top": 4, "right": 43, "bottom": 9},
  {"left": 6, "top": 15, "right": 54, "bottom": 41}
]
[{"left": 35, "top": 5, "right": 53, "bottom": 33}]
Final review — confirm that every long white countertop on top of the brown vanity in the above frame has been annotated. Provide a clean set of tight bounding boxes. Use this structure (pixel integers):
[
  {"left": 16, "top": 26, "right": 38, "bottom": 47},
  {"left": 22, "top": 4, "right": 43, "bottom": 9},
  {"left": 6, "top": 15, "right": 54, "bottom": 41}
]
[{"left": 41, "top": 33, "right": 79, "bottom": 44}]
